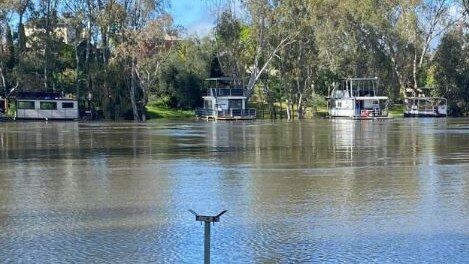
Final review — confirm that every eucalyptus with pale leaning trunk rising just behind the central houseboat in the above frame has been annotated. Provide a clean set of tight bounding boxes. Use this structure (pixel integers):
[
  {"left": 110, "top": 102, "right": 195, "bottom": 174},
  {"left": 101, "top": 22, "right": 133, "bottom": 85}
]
[{"left": 212, "top": 0, "right": 299, "bottom": 97}]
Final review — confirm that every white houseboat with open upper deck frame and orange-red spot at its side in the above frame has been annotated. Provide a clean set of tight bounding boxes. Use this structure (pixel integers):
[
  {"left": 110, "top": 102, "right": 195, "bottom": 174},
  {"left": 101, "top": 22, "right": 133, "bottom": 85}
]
[{"left": 326, "top": 77, "right": 389, "bottom": 119}]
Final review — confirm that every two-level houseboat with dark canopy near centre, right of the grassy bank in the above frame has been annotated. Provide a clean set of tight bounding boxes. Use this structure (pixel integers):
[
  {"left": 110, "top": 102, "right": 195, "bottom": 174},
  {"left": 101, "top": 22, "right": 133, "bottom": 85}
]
[{"left": 195, "top": 77, "right": 256, "bottom": 120}]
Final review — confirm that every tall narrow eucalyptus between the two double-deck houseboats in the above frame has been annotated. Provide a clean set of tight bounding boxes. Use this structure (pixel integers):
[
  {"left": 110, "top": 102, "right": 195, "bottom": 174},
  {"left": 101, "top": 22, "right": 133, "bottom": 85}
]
[{"left": 272, "top": 0, "right": 318, "bottom": 119}]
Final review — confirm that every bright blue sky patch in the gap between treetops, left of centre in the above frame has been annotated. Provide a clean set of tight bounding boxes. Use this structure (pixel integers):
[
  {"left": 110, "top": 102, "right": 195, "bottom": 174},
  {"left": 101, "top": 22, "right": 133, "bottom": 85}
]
[{"left": 168, "top": 0, "right": 215, "bottom": 36}]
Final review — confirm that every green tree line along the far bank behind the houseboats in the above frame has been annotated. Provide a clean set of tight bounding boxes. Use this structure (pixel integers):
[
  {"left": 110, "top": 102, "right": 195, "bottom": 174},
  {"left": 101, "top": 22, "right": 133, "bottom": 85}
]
[{"left": 0, "top": 0, "right": 469, "bottom": 121}]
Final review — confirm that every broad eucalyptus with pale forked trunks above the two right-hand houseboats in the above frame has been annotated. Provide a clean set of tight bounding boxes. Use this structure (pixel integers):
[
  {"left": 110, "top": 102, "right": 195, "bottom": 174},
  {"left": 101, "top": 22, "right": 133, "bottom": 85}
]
[{"left": 308, "top": 0, "right": 460, "bottom": 99}]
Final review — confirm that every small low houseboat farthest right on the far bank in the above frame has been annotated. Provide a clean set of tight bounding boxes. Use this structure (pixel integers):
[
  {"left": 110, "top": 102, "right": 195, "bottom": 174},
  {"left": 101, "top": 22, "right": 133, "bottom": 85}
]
[{"left": 404, "top": 88, "right": 447, "bottom": 117}]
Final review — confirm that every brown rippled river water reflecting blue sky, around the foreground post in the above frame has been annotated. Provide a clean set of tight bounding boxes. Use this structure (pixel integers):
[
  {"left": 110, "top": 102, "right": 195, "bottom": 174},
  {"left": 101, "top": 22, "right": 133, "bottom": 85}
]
[{"left": 0, "top": 118, "right": 469, "bottom": 263}]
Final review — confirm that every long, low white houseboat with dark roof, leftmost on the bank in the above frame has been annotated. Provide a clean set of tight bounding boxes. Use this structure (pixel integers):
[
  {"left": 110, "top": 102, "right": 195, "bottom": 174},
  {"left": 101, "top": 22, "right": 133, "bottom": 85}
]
[{"left": 15, "top": 92, "right": 79, "bottom": 120}]
